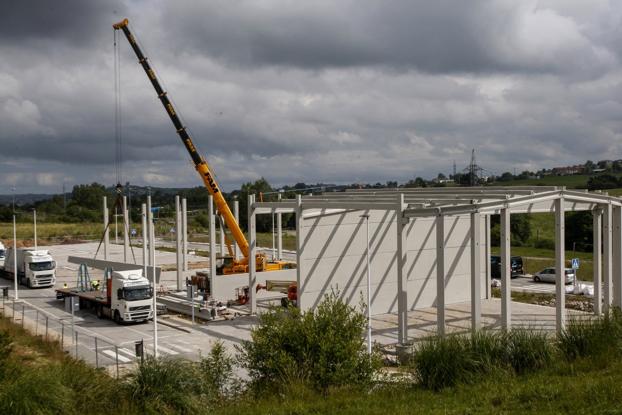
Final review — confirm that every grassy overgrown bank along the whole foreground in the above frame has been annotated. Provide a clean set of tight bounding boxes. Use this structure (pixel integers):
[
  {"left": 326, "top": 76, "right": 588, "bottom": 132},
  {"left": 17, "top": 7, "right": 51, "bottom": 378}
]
[{"left": 0, "top": 302, "right": 622, "bottom": 415}]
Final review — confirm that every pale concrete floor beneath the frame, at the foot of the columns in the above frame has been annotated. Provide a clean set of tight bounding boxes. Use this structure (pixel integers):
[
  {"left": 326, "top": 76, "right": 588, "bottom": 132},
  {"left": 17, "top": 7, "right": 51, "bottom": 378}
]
[{"left": 372, "top": 298, "right": 591, "bottom": 345}]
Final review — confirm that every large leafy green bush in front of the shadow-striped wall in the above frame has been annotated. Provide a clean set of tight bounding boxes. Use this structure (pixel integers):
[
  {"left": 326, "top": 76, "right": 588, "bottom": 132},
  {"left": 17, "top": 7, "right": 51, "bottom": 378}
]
[{"left": 240, "top": 293, "right": 379, "bottom": 392}]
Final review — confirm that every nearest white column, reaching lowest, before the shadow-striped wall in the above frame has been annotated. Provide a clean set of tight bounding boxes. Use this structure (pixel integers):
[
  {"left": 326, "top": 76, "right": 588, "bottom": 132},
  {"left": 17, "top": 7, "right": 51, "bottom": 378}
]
[{"left": 395, "top": 193, "right": 408, "bottom": 345}]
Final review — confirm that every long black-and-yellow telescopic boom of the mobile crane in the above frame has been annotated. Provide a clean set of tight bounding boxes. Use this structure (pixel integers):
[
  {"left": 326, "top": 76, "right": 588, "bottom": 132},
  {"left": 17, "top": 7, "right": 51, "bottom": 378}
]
[{"left": 112, "top": 19, "right": 249, "bottom": 262}]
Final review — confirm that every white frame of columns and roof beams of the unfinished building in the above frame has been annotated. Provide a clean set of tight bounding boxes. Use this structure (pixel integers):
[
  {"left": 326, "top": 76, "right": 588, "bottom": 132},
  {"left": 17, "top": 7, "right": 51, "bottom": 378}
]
[{"left": 248, "top": 186, "right": 622, "bottom": 344}]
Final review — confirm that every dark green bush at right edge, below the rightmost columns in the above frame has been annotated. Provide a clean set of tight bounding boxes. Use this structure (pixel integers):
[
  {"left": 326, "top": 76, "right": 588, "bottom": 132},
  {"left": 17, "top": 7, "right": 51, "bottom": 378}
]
[{"left": 557, "top": 308, "right": 622, "bottom": 360}]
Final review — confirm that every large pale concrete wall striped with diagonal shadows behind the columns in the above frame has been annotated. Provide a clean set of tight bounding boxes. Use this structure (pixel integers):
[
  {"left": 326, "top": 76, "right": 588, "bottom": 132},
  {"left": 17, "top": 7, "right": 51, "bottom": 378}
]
[{"left": 299, "top": 211, "right": 488, "bottom": 314}]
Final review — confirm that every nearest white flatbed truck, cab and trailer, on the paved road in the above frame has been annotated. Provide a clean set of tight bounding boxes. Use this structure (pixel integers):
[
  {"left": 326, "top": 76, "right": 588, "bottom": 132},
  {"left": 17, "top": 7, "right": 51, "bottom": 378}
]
[{"left": 56, "top": 270, "right": 153, "bottom": 324}]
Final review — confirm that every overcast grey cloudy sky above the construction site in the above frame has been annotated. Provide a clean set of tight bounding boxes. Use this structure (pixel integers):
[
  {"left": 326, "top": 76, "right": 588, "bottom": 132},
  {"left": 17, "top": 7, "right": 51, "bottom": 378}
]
[{"left": 0, "top": 0, "right": 622, "bottom": 193}]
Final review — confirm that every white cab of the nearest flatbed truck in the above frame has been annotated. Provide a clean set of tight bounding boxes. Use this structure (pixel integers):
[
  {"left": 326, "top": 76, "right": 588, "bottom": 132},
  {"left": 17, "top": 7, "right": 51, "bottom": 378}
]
[{"left": 107, "top": 270, "right": 153, "bottom": 322}]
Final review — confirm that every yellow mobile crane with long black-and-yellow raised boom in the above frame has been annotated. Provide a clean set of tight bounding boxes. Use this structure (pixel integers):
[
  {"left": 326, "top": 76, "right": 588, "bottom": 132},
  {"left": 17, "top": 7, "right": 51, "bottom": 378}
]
[{"left": 112, "top": 19, "right": 296, "bottom": 274}]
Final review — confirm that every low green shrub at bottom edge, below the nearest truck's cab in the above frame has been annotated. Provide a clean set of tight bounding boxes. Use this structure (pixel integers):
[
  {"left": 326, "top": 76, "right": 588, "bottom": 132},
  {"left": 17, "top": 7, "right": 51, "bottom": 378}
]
[{"left": 127, "top": 357, "right": 202, "bottom": 413}]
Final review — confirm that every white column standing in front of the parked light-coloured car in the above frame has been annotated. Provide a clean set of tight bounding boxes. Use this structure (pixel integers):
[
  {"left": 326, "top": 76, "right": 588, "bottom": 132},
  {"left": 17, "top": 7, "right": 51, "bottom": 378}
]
[{"left": 555, "top": 196, "right": 566, "bottom": 331}]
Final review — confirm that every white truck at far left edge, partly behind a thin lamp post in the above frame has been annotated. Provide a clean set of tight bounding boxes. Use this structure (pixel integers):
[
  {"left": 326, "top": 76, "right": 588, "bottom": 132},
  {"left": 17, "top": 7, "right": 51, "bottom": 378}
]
[{"left": 1, "top": 247, "right": 56, "bottom": 288}]
